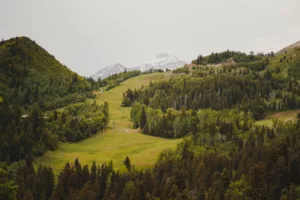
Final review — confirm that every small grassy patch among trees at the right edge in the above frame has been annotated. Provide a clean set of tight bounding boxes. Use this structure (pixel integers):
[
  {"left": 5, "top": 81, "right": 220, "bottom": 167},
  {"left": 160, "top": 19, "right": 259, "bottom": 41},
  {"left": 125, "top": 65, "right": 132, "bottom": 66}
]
[{"left": 256, "top": 109, "right": 300, "bottom": 126}]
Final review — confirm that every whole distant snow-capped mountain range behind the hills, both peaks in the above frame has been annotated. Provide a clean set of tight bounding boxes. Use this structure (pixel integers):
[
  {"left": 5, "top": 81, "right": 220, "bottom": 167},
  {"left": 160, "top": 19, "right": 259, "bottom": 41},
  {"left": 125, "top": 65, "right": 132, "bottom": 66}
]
[{"left": 91, "top": 53, "right": 186, "bottom": 80}]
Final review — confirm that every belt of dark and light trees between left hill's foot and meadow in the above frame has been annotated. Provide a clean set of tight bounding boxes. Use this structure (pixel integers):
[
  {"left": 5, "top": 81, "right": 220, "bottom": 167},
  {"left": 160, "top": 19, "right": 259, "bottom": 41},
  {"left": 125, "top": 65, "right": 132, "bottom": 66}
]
[{"left": 0, "top": 100, "right": 108, "bottom": 162}]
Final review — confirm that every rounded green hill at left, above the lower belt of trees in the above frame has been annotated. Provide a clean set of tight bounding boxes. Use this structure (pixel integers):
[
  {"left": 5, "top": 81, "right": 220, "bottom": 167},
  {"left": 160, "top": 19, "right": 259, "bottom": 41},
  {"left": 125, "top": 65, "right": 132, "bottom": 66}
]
[{"left": 0, "top": 37, "right": 90, "bottom": 108}]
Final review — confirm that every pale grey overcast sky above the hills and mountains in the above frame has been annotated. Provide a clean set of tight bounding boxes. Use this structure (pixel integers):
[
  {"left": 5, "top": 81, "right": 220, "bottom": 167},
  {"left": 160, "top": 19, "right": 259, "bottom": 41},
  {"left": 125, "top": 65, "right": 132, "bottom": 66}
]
[{"left": 0, "top": 0, "right": 300, "bottom": 76}]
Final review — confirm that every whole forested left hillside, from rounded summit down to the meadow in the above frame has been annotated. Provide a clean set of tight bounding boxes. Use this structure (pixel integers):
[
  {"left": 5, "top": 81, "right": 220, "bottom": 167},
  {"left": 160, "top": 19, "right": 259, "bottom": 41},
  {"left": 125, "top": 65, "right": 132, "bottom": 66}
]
[{"left": 0, "top": 37, "right": 109, "bottom": 194}]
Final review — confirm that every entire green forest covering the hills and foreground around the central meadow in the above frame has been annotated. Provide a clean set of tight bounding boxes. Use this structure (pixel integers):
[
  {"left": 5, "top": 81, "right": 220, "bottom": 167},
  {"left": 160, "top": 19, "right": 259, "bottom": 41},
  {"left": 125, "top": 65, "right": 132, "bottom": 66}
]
[{"left": 0, "top": 38, "right": 300, "bottom": 200}]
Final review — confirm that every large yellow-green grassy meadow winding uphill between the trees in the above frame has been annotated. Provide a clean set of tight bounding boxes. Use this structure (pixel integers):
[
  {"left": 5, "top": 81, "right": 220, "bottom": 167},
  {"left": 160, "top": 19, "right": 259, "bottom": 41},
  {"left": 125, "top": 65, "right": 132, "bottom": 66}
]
[{"left": 35, "top": 73, "right": 181, "bottom": 174}]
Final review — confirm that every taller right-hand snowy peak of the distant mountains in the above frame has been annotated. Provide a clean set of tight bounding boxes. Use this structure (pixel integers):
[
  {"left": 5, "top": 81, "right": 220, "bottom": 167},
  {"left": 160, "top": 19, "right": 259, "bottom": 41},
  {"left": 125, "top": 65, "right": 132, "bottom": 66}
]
[{"left": 133, "top": 53, "right": 186, "bottom": 71}]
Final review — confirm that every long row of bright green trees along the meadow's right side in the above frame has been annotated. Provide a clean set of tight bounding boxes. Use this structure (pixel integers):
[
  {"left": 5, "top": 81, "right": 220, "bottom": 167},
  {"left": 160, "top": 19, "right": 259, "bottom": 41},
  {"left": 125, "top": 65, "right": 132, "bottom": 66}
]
[{"left": 131, "top": 103, "right": 254, "bottom": 138}]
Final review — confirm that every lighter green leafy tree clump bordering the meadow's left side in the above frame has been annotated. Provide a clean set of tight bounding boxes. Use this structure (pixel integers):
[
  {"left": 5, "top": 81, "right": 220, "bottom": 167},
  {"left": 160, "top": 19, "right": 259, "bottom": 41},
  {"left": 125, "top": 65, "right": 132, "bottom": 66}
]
[{"left": 47, "top": 102, "right": 109, "bottom": 142}]
